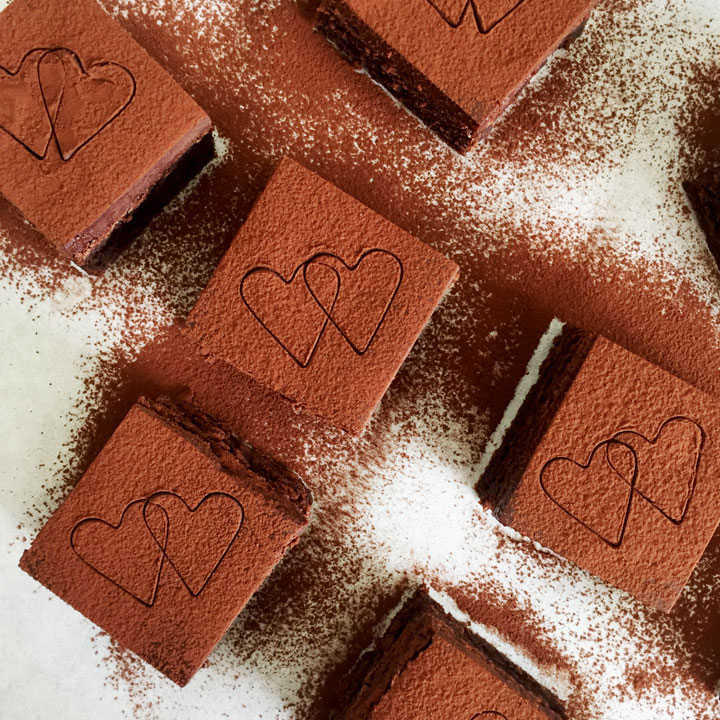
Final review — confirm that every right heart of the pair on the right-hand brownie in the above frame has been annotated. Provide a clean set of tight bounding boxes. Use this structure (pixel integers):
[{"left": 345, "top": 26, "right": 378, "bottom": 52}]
[{"left": 607, "top": 416, "right": 705, "bottom": 525}]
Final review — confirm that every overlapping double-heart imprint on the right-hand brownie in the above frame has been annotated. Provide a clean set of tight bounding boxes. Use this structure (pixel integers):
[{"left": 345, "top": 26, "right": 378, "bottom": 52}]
[{"left": 540, "top": 415, "right": 705, "bottom": 548}]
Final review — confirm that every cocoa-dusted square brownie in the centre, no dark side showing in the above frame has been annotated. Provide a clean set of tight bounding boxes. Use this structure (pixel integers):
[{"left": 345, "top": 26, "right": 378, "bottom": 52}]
[{"left": 187, "top": 159, "right": 458, "bottom": 433}]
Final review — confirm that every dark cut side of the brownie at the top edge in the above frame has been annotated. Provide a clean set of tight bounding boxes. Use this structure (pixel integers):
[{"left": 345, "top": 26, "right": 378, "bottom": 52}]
[{"left": 315, "top": 0, "right": 481, "bottom": 153}]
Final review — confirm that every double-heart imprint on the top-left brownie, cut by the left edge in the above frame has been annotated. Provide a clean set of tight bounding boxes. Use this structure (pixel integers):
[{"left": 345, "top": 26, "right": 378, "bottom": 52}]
[{"left": 0, "top": 47, "right": 136, "bottom": 162}]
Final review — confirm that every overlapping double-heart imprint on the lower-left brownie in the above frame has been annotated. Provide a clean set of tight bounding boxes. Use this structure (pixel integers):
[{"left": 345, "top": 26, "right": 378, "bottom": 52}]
[{"left": 70, "top": 491, "right": 245, "bottom": 607}]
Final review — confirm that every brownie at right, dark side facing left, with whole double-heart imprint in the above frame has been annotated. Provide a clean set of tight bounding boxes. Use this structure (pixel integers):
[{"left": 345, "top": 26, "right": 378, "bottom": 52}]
[{"left": 477, "top": 327, "right": 720, "bottom": 612}]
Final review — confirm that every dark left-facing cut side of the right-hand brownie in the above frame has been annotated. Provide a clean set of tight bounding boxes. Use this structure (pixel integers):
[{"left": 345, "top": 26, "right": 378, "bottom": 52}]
[{"left": 475, "top": 325, "right": 597, "bottom": 523}]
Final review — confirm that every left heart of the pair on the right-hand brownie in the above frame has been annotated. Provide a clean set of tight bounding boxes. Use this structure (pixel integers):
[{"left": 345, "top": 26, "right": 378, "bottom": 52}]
[{"left": 540, "top": 439, "right": 638, "bottom": 548}]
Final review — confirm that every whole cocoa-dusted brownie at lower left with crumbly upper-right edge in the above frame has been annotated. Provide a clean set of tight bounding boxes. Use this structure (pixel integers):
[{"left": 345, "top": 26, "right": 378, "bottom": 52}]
[{"left": 20, "top": 399, "right": 312, "bottom": 685}]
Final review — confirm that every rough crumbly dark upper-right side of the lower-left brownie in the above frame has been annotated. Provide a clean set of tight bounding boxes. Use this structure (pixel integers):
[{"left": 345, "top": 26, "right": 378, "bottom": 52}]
[{"left": 138, "top": 397, "right": 313, "bottom": 525}]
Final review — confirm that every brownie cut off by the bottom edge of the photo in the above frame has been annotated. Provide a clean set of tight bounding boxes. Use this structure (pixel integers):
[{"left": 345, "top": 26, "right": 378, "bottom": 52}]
[{"left": 336, "top": 590, "right": 566, "bottom": 720}]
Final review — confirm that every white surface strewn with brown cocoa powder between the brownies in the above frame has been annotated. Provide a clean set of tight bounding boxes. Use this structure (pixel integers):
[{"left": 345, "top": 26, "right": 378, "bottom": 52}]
[{"left": 0, "top": 0, "right": 720, "bottom": 720}]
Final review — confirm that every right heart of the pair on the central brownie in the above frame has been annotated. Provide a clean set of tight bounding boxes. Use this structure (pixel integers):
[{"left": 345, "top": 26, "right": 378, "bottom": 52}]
[{"left": 303, "top": 248, "right": 404, "bottom": 355}]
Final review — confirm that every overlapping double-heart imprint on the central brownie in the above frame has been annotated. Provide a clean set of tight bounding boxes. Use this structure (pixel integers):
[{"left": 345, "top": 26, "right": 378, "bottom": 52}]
[{"left": 240, "top": 248, "right": 404, "bottom": 368}]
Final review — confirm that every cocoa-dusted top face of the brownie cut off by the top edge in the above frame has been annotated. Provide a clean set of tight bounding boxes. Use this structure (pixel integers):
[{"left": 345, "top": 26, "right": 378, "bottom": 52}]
[{"left": 325, "top": 0, "right": 597, "bottom": 131}]
